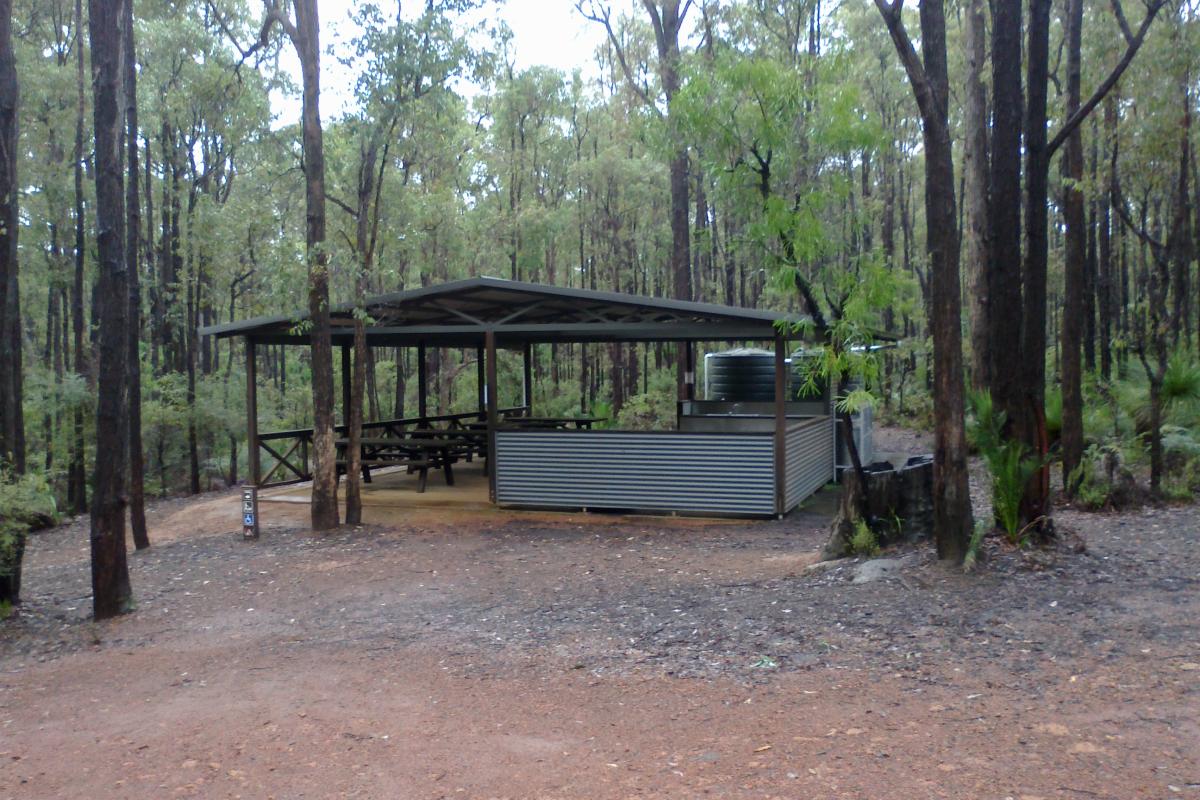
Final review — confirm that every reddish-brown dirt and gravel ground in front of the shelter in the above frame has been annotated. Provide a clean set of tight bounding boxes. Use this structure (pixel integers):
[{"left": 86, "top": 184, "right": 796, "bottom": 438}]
[{"left": 0, "top": 434, "right": 1200, "bottom": 800}]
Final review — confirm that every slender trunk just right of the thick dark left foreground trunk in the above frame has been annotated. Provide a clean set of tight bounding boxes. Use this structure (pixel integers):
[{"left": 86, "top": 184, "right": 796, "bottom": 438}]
[{"left": 122, "top": 0, "right": 150, "bottom": 551}]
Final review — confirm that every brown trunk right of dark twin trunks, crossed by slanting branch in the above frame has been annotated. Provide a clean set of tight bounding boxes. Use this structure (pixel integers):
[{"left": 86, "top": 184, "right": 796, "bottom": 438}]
[{"left": 1061, "top": 0, "right": 1087, "bottom": 497}]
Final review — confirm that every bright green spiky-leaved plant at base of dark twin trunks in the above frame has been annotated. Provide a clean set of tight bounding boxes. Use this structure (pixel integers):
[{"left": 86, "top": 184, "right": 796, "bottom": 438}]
[{"left": 967, "top": 392, "right": 1045, "bottom": 545}]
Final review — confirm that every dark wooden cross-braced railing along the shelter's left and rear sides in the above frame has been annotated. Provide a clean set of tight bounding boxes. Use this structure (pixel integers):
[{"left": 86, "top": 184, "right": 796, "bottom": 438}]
[{"left": 253, "top": 405, "right": 529, "bottom": 488}]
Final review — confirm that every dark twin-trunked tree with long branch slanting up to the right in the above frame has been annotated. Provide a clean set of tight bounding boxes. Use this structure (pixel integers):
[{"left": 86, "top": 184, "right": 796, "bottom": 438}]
[{"left": 988, "top": 0, "right": 1165, "bottom": 522}]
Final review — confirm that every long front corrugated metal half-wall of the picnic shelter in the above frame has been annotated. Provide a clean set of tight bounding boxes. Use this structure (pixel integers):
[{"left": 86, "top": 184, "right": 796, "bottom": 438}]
[{"left": 496, "top": 431, "right": 777, "bottom": 516}]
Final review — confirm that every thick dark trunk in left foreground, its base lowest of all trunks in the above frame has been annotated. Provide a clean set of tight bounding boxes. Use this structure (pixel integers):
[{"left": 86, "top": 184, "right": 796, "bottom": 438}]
[{"left": 88, "top": 0, "right": 132, "bottom": 619}]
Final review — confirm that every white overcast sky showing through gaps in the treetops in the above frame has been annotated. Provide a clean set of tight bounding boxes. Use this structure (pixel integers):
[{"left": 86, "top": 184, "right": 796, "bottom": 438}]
[{"left": 271, "top": 0, "right": 609, "bottom": 126}]
